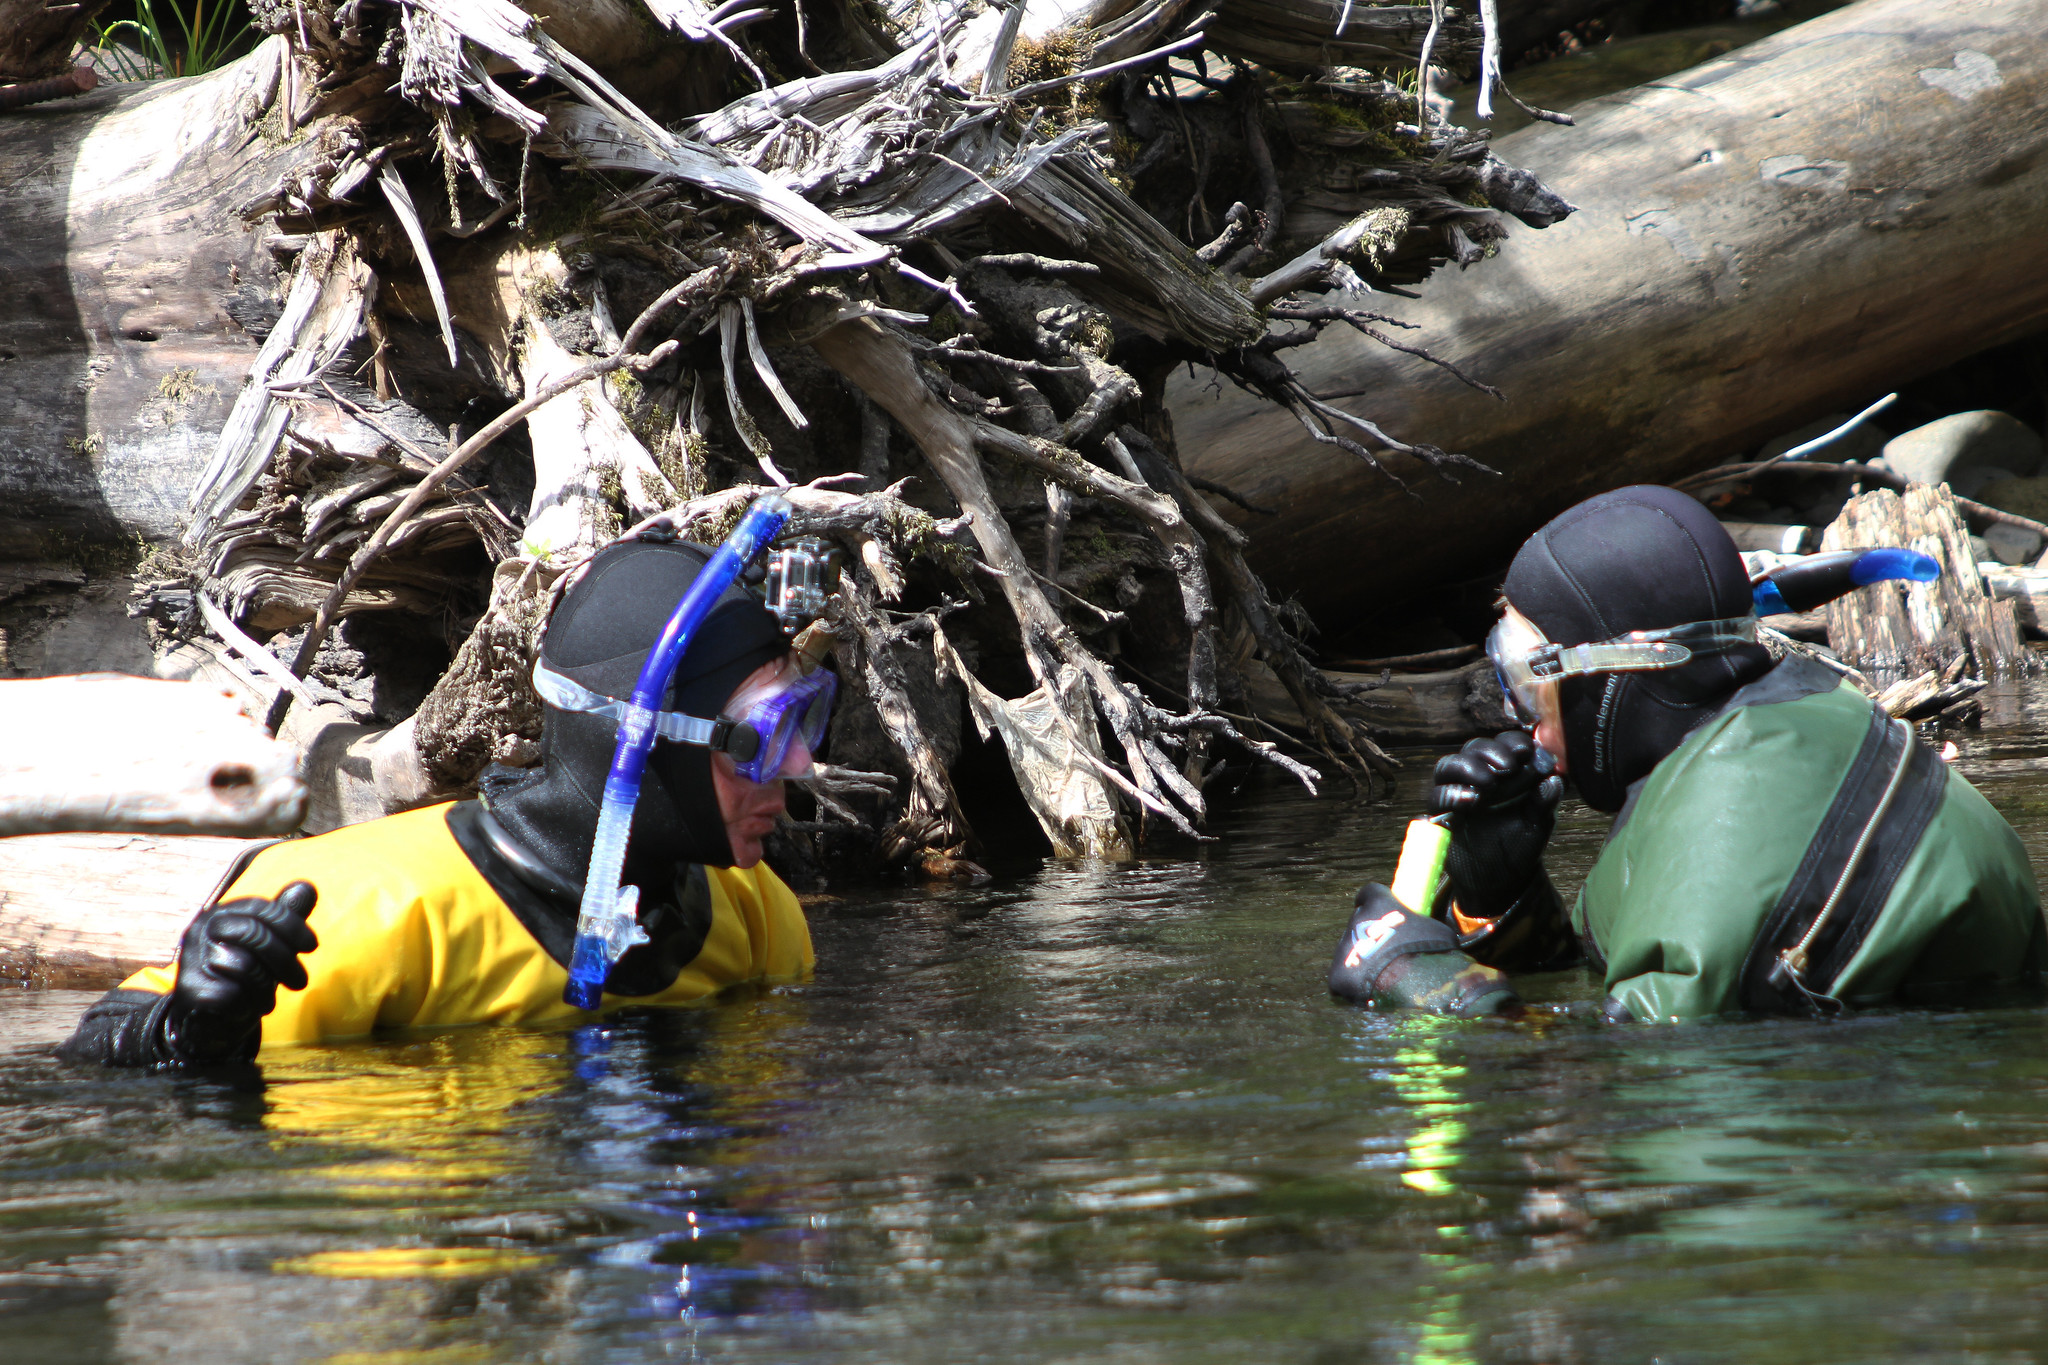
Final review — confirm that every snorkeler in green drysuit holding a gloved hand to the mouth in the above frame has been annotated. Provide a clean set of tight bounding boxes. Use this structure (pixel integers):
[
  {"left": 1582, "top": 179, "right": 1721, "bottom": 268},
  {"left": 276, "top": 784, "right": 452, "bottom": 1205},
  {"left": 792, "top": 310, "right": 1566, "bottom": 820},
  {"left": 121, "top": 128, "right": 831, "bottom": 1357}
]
[{"left": 1331, "top": 487, "right": 2048, "bottom": 1019}]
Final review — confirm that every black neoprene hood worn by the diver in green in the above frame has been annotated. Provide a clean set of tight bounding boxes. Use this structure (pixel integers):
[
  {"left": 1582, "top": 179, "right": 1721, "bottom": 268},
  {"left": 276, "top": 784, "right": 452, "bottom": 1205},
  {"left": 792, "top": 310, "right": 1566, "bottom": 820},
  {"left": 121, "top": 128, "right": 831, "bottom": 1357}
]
[{"left": 1501, "top": 485, "right": 1772, "bottom": 810}]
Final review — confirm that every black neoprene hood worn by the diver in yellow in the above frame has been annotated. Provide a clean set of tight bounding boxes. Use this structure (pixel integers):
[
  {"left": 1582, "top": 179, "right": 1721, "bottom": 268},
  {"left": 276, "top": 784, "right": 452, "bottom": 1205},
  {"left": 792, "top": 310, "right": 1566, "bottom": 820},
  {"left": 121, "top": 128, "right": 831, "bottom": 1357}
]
[{"left": 483, "top": 540, "right": 788, "bottom": 888}]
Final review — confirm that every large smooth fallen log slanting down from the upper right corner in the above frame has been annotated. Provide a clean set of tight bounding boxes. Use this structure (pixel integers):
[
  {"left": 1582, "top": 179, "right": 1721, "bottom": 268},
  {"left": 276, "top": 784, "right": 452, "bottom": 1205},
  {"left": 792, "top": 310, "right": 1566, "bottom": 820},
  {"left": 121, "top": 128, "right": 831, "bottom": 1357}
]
[{"left": 1171, "top": 0, "right": 2048, "bottom": 630}]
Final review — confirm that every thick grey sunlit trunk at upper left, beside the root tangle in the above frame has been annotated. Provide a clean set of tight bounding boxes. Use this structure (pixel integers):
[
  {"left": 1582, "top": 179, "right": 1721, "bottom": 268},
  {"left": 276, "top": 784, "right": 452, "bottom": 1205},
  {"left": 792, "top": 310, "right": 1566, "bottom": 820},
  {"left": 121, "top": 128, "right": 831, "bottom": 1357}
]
[{"left": 0, "top": 39, "right": 309, "bottom": 559}]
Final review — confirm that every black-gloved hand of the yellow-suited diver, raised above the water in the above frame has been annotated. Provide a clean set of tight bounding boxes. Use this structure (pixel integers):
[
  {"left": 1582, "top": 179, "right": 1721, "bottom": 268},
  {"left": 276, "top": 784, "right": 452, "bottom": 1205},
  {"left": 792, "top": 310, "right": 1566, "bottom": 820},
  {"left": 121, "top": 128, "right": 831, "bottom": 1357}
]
[{"left": 160, "top": 882, "right": 319, "bottom": 1064}]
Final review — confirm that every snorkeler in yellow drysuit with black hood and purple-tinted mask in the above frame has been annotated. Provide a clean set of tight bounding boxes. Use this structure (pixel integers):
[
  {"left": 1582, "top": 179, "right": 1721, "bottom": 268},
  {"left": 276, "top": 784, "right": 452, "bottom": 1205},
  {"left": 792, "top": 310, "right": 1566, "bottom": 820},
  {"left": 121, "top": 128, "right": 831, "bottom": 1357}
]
[{"left": 63, "top": 538, "right": 829, "bottom": 1066}]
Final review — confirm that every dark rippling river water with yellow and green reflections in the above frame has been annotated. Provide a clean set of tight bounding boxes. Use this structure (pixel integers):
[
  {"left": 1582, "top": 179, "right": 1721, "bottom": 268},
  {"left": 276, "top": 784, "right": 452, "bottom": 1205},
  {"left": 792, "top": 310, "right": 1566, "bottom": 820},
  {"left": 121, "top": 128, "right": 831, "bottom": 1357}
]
[{"left": 0, "top": 698, "right": 2048, "bottom": 1365}]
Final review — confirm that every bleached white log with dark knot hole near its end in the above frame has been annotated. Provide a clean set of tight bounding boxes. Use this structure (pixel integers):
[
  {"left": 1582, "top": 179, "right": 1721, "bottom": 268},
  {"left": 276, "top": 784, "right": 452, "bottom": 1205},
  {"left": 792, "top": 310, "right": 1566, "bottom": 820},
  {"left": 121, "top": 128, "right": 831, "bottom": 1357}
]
[{"left": 0, "top": 673, "right": 305, "bottom": 835}]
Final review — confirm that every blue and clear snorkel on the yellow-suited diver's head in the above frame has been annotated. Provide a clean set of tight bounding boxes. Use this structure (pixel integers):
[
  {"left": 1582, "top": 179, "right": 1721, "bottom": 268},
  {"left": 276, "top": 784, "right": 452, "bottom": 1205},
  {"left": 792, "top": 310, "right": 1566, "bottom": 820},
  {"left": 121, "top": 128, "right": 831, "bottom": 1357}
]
[{"left": 561, "top": 493, "right": 791, "bottom": 1009}]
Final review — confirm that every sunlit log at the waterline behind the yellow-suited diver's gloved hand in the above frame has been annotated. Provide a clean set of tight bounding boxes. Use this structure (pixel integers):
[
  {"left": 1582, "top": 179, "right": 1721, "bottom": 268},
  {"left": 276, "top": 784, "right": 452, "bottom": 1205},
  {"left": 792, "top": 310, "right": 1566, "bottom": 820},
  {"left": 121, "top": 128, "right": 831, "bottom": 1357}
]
[{"left": 0, "top": 835, "right": 264, "bottom": 990}]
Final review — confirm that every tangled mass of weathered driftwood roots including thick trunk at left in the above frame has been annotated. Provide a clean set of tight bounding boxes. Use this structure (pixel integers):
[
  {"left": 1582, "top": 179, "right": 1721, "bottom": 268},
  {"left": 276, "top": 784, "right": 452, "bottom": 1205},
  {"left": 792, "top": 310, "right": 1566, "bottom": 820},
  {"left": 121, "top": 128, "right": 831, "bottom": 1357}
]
[{"left": 0, "top": 0, "right": 1571, "bottom": 855}]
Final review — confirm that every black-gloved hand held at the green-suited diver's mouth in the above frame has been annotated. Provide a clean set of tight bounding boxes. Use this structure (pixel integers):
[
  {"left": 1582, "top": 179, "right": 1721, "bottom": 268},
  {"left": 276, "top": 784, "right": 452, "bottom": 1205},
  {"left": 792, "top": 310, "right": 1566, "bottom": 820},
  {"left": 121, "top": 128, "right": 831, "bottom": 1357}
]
[{"left": 1427, "top": 731, "right": 1565, "bottom": 919}]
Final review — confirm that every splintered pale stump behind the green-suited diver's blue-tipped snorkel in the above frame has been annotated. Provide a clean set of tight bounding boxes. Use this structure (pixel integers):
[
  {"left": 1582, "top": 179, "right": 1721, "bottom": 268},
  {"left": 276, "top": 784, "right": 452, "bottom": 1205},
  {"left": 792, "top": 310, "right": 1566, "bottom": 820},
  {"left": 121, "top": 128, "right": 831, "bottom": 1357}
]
[{"left": 1821, "top": 483, "right": 2032, "bottom": 686}]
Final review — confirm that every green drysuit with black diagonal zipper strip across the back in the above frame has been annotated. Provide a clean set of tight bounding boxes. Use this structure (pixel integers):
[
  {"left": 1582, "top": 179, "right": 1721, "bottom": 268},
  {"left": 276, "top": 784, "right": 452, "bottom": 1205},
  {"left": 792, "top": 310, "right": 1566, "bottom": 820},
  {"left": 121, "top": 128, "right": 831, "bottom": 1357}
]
[{"left": 1571, "top": 659, "right": 2044, "bottom": 1019}]
